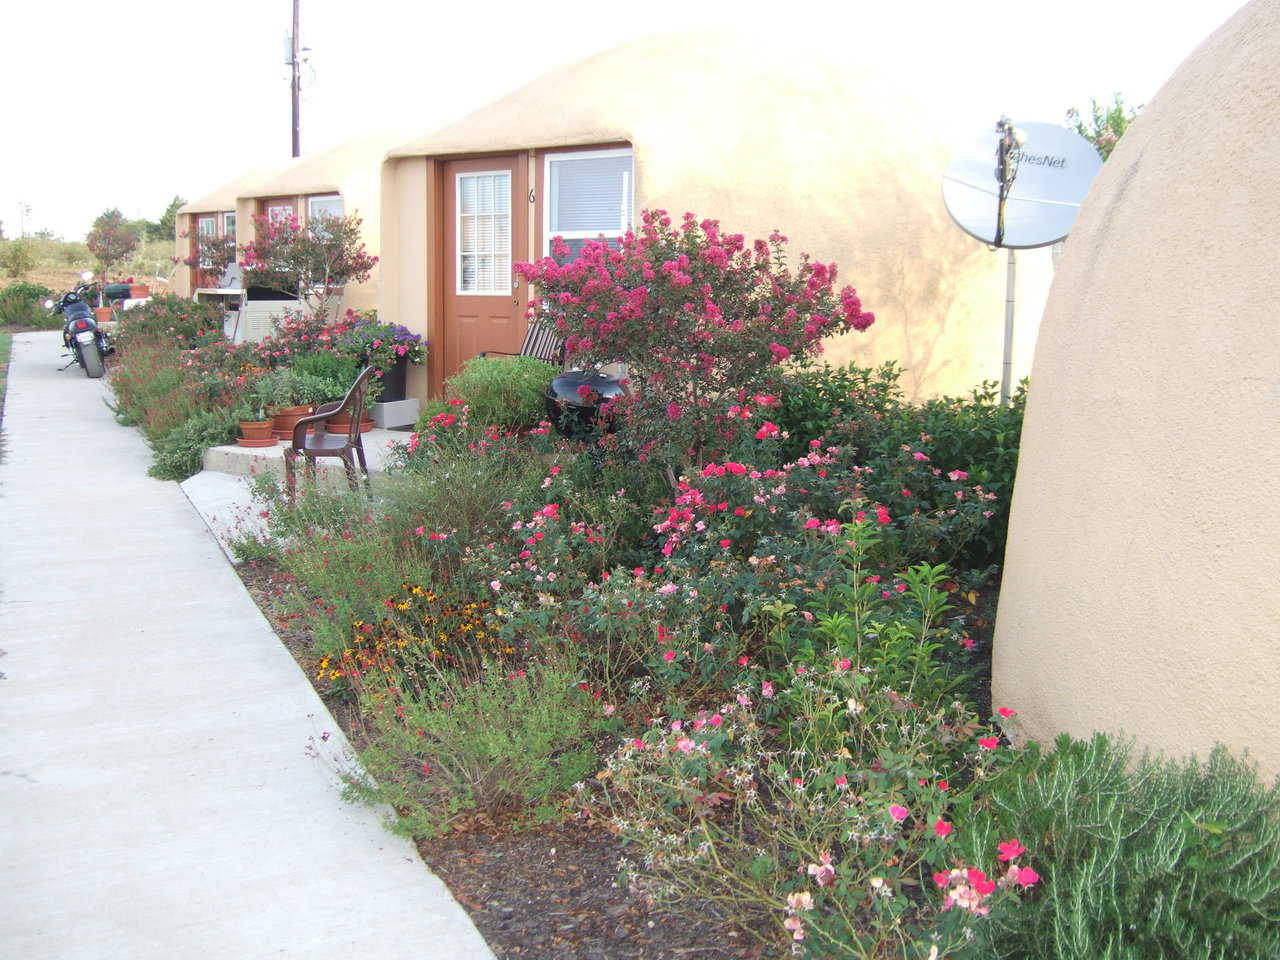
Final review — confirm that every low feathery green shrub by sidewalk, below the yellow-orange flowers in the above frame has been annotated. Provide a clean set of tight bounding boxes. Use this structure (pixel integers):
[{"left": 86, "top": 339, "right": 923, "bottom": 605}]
[{"left": 349, "top": 657, "right": 608, "bottom": 837}]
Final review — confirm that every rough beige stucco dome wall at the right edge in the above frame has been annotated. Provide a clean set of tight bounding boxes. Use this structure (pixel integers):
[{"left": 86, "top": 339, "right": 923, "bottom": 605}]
[{"left": 995, "top": 0, "right": 1280, "bottom": 774}]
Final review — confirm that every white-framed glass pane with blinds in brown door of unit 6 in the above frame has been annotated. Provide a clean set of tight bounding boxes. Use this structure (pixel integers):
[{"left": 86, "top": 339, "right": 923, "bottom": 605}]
[{"left": 457, "top": 170, "right": 511, "bottom": 296}]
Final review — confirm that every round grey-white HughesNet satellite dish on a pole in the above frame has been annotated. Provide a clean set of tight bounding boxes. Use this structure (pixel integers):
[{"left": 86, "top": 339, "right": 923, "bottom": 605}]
[{"left": 942, "top": 123, "right": 1102, "bottom": 250}]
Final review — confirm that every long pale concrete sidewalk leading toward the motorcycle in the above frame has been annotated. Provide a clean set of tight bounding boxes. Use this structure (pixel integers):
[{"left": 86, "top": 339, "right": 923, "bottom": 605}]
[{"left": 0, "top": 334, "right": 492, "bottom": 960}]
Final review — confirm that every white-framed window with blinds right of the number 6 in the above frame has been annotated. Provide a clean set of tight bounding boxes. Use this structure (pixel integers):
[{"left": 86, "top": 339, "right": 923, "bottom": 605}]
[{"left": 543, "top": 148, "right": 635, "bottom": 259}]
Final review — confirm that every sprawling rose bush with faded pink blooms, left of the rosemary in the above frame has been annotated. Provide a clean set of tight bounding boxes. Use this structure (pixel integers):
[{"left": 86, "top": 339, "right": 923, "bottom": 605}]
[{"left": 598, "top": 524, "right": 1018, "bottom": 960}]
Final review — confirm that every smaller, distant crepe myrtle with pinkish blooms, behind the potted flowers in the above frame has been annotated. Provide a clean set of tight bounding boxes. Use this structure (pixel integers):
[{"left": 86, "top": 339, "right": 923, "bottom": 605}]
[{"left": 241, "top": 214, "right": 378, "bottom": 323}]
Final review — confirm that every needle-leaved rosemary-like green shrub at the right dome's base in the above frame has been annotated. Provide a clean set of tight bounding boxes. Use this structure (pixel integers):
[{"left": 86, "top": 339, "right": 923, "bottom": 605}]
[{"left": 964, "top": 733, "right": 1280, "bottom": 960}]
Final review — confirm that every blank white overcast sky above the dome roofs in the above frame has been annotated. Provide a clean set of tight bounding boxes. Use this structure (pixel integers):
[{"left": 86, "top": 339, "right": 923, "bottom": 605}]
[{"left": 0, "top": 0, "right": 1242, "bottom": 239}]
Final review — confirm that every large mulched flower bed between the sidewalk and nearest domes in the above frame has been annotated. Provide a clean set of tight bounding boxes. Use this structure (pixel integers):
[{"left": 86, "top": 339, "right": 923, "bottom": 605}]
[{"left": 113, "top": 211, "right": 1280, "bottom": 960}]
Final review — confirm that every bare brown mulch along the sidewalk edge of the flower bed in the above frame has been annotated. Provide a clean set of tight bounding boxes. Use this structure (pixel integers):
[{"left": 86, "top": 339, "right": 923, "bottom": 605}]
[{"left": 237, "top": 562, "right": 772, "bottom": 960}]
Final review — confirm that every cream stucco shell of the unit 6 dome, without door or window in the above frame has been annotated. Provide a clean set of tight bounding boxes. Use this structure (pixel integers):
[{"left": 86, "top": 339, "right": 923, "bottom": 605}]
[{"left": 383, "top": 32, "right": 1051, "bottom": 396}]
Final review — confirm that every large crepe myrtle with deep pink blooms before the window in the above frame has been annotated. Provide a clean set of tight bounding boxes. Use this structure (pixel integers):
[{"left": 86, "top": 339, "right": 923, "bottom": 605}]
[{"left": 516, "top": 210, "right": 876, "bottom": 470}]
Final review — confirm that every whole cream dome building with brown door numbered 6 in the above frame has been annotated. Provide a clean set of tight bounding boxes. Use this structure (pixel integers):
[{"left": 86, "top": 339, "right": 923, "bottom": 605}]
[{"left": 380, "top": 32, "right": 1051, "bottom": 396}]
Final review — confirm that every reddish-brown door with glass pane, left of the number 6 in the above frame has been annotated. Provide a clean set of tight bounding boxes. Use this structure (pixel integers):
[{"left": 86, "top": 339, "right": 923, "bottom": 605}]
[{"left": 440, "top": 156, "right": 529, "bottom": 379}]
